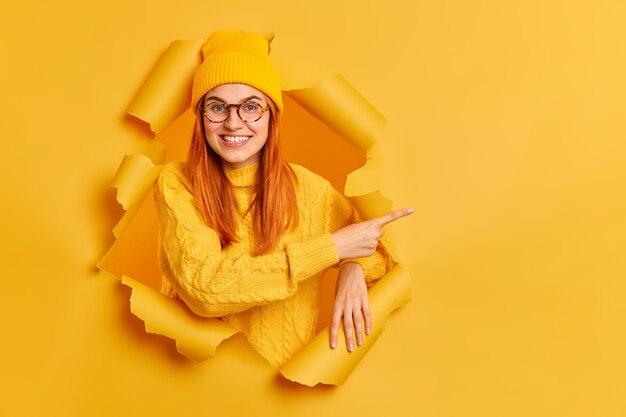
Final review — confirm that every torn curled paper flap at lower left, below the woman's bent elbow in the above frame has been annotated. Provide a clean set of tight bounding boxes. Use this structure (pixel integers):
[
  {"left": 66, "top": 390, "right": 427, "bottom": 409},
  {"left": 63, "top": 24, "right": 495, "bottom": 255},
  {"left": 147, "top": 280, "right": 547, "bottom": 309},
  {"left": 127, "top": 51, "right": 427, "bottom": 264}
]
[{"left": 122, "top": 276, "right": 238, "bottom": 362}]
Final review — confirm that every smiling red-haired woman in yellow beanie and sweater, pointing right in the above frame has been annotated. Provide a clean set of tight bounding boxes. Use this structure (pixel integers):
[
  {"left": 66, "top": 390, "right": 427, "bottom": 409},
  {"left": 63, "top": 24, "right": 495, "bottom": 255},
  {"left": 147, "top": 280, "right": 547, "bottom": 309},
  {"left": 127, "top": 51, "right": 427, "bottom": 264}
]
[{"left": 155, "top": 31, "right": 411, "bottom": 367}]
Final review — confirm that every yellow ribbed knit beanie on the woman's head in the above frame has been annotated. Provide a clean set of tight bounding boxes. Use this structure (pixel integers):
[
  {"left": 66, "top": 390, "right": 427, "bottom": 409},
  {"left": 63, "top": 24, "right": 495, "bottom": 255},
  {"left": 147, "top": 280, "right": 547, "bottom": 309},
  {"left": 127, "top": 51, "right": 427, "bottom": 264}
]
[{"left": 191, "top": 30, "right": 283, "bottom": 113}]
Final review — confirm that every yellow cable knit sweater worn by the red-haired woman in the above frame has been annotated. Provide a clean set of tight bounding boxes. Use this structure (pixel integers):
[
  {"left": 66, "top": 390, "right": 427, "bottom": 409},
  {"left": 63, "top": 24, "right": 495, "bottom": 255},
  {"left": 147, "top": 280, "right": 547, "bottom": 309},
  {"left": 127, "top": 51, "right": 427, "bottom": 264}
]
[{"left": 155, "top": 162, "right": 389, "bottom": 367}]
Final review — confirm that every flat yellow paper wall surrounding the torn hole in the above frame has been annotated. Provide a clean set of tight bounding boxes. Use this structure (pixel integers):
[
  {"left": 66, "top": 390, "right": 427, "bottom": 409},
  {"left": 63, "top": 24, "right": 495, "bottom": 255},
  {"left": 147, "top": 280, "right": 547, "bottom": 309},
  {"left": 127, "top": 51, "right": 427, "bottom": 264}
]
[{"left": 0, "top": 0, "right": 626, "bottom": 417}]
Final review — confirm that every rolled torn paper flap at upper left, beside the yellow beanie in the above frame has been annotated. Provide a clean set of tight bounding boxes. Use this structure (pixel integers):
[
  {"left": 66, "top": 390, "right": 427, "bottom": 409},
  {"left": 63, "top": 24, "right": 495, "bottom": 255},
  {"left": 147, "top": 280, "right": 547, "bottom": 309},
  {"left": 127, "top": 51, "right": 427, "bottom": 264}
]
[{"left": 127, "top": 40, "right": 204, "bottom": 133}]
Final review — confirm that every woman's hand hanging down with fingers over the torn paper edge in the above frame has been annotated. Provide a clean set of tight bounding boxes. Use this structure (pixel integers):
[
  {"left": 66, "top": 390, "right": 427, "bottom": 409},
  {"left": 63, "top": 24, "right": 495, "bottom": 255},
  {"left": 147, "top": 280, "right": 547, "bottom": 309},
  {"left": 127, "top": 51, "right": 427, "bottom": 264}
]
[{"left": 330, "top": 262, "right": 372, "bottom": 352}]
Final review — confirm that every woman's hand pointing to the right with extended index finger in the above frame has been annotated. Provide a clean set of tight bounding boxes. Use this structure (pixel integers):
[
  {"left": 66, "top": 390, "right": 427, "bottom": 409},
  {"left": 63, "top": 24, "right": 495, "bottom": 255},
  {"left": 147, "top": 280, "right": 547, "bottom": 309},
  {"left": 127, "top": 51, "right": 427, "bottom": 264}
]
[{"left": 332, "top": 209, "right": 413, "bottom": 259}]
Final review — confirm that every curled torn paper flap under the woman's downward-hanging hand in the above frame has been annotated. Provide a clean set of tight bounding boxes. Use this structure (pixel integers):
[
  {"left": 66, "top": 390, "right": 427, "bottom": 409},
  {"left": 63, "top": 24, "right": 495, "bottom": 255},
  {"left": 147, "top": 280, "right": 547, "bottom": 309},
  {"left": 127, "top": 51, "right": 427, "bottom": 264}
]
[{"left": 280, "top": 265, "right": 411, "bottom": 386}]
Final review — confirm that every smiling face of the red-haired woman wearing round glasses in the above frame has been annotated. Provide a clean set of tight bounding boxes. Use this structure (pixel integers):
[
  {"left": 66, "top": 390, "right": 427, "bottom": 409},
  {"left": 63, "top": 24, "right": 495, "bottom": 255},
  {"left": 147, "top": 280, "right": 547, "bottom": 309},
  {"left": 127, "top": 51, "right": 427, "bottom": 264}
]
[{"left": 201, "top": 84, "right": 270, "bottom": 169}]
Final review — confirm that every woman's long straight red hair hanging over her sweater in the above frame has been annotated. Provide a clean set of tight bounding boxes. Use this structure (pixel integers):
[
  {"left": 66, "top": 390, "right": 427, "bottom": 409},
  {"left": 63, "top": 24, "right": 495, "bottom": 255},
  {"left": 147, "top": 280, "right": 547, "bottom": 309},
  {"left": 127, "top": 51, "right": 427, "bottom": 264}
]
[{"left": 186, "top": 98, "right": 298, "bottom": 255}]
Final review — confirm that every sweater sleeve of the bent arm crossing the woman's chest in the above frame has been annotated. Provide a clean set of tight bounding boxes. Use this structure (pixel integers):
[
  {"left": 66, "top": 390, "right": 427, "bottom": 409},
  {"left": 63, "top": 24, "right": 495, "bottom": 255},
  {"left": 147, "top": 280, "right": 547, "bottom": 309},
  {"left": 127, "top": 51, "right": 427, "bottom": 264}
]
[{"left": 154, "top": 164, "right": 338, "bottom": 317}]
